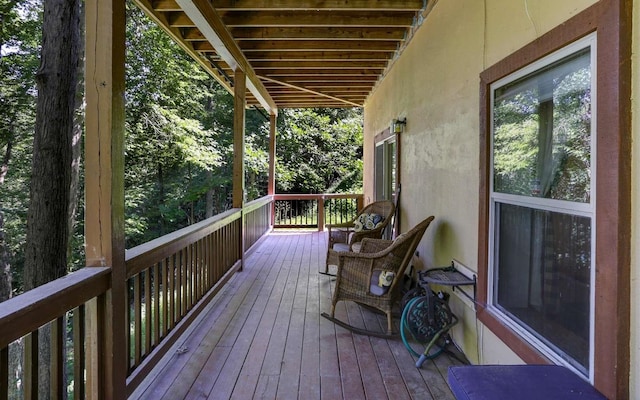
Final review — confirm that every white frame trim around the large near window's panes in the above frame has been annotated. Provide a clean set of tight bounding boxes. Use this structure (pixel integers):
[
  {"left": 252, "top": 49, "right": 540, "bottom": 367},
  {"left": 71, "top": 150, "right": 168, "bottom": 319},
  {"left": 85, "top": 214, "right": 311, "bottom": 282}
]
[{"left": 487, "top": 32, "right": 598, "bottom": 384}]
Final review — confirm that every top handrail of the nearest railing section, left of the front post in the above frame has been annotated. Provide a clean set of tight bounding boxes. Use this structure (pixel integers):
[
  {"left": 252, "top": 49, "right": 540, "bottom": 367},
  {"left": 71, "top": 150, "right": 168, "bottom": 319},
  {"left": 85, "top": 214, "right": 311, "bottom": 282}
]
[{"left": 0, "top": 267, "right": 111, "bottom": 349}]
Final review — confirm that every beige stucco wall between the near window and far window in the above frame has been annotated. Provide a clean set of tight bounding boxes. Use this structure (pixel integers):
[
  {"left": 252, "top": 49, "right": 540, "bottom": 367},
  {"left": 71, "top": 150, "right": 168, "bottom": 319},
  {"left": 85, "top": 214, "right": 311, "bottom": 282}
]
[{"left": 364, "top": 0, "right": 604, "bottom": 363}]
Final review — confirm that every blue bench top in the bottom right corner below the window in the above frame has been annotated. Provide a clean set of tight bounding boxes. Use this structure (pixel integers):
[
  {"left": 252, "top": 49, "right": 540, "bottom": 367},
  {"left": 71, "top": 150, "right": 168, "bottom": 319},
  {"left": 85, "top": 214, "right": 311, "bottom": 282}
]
[{"left": 448, "top": 365, "right": 606, "bottom": 400}]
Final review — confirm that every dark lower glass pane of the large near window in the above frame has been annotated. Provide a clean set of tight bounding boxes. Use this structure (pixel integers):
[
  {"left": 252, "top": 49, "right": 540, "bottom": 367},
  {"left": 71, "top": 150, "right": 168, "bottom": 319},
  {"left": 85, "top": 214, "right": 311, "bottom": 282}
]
[{"left": 494, "top": 203, "right": 591, "bottom": 371}]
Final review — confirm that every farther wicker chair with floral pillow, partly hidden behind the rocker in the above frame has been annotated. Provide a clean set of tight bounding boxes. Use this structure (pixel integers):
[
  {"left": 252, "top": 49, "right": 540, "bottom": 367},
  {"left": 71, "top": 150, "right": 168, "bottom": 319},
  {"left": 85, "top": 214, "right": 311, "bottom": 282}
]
[{"left": 321, "top": 200, "right": 395, "bottom": 275}]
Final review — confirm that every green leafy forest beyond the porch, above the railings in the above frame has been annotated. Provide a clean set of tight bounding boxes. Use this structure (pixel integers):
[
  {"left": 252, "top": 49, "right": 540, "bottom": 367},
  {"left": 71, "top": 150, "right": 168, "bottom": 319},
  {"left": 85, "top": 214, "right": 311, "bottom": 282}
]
[{"left": 0, "top": 0, "right": 362, "bottom": 301}]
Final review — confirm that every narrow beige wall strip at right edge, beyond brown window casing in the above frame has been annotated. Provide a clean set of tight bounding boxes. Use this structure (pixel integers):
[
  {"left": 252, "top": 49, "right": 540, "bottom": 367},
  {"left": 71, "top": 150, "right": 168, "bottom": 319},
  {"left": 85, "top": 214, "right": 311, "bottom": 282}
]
[{"left": 629, "top": 1, "right": 640, "bottom": 399}]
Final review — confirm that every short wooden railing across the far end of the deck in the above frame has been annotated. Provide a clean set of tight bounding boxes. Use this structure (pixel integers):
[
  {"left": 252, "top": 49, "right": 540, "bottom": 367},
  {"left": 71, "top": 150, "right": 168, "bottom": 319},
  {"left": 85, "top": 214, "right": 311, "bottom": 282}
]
[{"left": 273, "top": 194, "right": 363, "bottom": 231}]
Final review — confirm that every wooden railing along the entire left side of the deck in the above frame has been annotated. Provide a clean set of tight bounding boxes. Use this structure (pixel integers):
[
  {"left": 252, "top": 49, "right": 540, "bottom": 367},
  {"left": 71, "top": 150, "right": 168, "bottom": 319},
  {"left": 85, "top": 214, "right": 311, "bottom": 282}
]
[{"left": 0, "top": 196, "right": 273, "bottom": 400}]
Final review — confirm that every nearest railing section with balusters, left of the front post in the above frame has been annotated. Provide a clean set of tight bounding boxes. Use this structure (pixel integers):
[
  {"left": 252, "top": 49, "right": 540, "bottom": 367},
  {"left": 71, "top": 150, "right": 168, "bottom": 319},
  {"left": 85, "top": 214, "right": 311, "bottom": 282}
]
[{"left": 0, "top": 267, "right": 111, "bottom": 399}]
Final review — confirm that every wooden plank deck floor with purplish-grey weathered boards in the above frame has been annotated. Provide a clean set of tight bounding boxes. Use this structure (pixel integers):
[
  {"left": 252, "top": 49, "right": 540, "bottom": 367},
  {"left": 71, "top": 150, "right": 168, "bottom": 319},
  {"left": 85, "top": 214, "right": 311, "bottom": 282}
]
[{"left": 130, "top": 231, "right": 459, "bottom": 400}]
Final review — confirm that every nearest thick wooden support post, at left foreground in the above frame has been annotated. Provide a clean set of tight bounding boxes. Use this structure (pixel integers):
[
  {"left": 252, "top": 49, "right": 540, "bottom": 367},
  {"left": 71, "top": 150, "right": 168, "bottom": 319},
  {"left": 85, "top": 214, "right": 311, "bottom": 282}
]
[{"left": 85, "top": 0, "right": 128, "bottom": 399}]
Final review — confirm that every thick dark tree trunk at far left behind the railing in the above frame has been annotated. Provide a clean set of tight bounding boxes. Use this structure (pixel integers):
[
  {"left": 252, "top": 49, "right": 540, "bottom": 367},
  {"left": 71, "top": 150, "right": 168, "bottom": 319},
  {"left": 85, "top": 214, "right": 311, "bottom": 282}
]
[{"left": 24, "top": 0, "right": 80, "bottom": 398}]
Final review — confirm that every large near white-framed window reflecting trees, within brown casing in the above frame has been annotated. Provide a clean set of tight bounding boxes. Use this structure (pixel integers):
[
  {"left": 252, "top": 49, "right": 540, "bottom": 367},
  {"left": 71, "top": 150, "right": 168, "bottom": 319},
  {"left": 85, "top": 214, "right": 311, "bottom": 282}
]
[{"left": 487, "top": 34, "right": 596, "bottom": 377}]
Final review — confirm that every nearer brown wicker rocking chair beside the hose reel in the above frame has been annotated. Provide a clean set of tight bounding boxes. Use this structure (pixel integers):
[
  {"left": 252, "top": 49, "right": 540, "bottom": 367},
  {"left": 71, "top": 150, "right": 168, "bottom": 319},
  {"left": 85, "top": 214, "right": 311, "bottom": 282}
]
[{"left": 322, "top": 216, "right": 434, "bottom": 337}]
